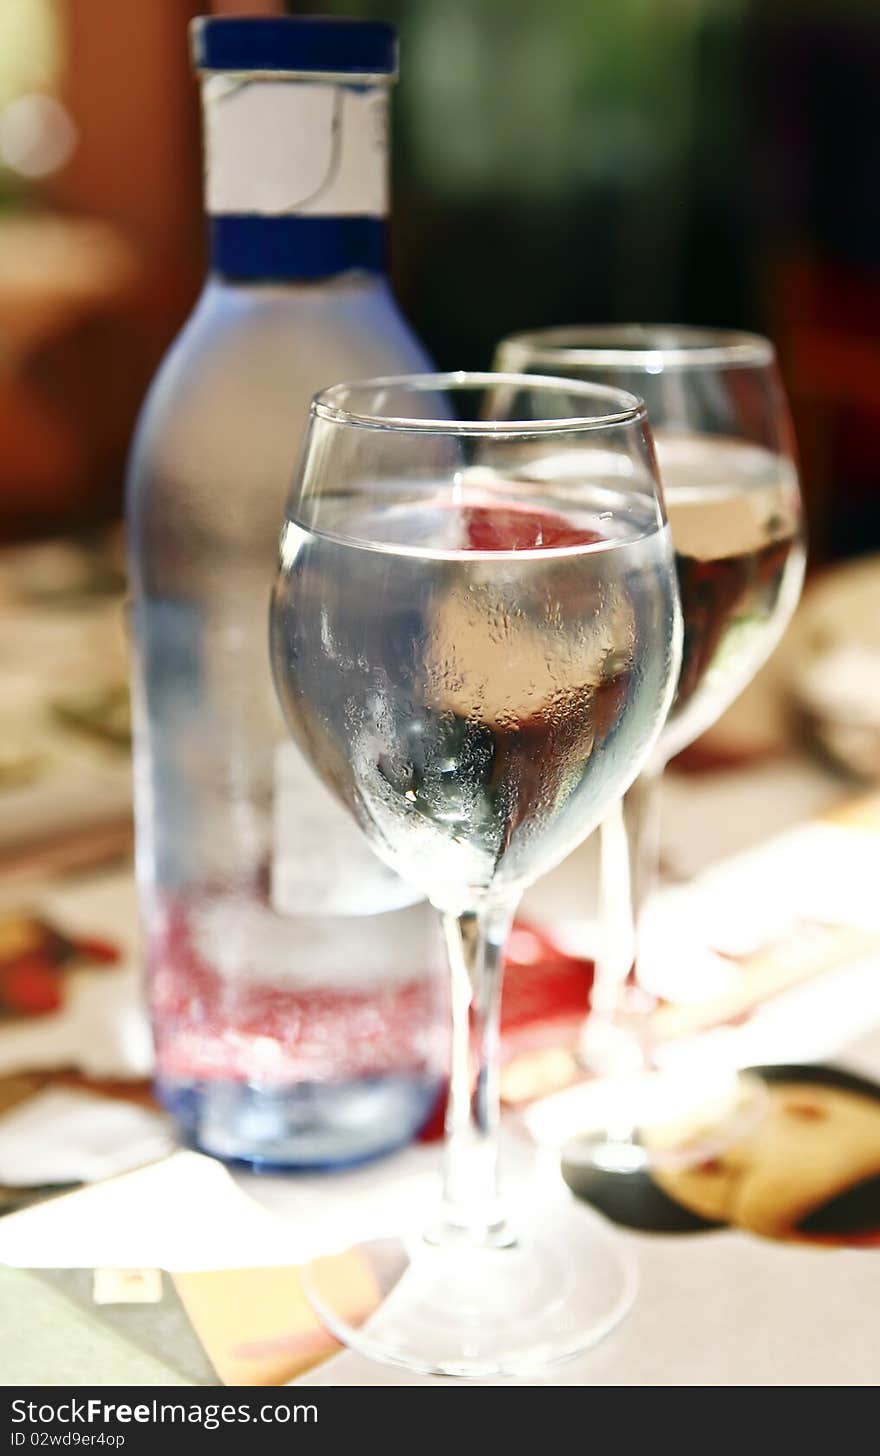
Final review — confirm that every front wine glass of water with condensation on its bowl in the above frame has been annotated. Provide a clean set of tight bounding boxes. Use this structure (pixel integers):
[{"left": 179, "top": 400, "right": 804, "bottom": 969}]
[{"left": 271, "top": 373, "right": 680, "bottom": 1376}]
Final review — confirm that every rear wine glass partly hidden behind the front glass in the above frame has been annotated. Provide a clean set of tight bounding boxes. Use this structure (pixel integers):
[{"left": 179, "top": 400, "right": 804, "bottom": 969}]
[{"left": 495, "top": 325, "right": 804, "bottom": 1172}]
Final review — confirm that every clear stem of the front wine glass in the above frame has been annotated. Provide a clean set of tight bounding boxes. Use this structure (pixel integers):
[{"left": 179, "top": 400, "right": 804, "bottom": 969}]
[{"left": 437, "top": 904, "right": 516, "bottom": 1243}]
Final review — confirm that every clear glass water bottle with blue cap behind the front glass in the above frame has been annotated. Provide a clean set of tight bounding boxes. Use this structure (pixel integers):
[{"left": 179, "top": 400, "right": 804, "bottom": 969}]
[{"left": 127, "top": 17, "right": 443, "bottom": 1168}]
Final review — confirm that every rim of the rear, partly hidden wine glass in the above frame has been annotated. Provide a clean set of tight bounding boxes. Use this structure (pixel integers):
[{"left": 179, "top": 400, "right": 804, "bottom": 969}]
[{"left": 498, "top": 323, "right": 777, "bottom": 373}]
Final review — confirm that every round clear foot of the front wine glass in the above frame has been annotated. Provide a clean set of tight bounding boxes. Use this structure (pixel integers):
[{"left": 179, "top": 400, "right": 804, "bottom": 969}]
[{"left": 303, "top": 1204, "right": 637, "bottom": 1379}]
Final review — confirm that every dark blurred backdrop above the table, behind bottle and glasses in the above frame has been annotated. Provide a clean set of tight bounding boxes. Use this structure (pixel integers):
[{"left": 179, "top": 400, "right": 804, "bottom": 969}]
[{"left": 0, "top": 0, "right": 880, "bottom": 563}]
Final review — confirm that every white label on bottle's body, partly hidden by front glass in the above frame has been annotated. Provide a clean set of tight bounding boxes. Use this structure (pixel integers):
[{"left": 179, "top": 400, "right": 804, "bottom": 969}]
[{"left": 271, "top": 743, "right": 421, "bottom": 916}]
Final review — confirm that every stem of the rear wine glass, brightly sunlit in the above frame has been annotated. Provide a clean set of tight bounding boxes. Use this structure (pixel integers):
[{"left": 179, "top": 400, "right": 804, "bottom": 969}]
[{"left": 583, "top": 766, "right": 663, "bottom": 1076}]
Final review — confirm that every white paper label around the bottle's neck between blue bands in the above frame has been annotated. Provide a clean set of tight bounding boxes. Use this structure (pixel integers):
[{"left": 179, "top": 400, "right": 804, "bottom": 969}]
[{"left": 204, "top": 76, "right": 388, "bottom": 217}]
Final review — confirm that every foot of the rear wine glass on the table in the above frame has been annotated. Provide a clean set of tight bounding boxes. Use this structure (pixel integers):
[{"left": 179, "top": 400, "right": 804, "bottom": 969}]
[{"left": 562, "top": 1072, "right": 768, "bottom": 1174}]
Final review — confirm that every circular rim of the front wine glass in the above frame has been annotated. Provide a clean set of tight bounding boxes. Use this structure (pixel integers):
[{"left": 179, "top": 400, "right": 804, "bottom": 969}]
[{"left": 309, "top": 370, "right": 647, "bottom": 438}]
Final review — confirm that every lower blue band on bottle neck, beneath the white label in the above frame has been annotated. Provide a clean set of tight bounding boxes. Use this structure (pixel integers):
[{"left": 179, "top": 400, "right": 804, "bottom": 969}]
[{"left": 208, "top": 213, "right": 388, "bottom": 281}]
